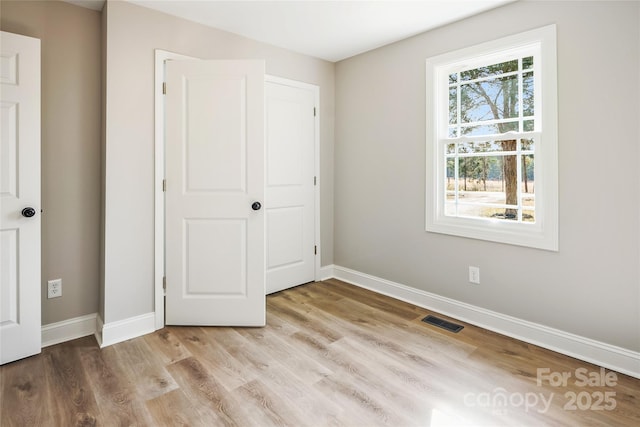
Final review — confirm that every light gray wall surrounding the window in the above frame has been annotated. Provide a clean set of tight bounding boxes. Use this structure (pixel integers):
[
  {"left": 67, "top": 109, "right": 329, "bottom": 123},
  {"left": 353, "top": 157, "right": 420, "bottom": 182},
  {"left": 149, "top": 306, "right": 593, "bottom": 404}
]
[{"left": 334, "top": 1, "right": 640, "bottom": 351}]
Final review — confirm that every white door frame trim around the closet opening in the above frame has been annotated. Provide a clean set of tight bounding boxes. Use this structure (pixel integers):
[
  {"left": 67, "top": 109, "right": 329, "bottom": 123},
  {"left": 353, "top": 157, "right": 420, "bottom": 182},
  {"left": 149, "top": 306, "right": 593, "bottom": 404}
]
[{"left": 154, "top": 49, "right": 322, "bottom": 330}]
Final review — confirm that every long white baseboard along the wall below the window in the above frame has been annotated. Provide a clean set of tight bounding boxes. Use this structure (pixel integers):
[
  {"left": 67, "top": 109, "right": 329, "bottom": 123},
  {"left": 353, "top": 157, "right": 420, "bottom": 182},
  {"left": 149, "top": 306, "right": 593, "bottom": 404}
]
[{"left": 330, "top": 265, "right": 640, "bottom": 378}]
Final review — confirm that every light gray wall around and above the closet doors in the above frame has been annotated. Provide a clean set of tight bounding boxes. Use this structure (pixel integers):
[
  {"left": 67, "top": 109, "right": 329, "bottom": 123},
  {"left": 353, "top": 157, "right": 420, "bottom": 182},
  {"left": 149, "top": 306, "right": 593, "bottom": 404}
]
[{"left": 101, "top": 1, "right": 335, "bottom": 323}]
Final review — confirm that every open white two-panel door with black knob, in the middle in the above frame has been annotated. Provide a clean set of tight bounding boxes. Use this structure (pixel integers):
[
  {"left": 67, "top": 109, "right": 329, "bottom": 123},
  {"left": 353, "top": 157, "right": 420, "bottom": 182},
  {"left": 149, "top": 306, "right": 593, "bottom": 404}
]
[{"left": 165, "top": 61, "right": 266, "bottom": 326}]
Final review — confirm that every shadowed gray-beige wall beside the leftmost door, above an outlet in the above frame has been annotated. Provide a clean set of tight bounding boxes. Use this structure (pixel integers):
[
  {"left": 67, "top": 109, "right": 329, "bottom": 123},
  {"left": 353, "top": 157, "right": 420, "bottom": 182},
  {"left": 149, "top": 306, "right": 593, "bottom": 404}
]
[{"left": 0, "top": 0, "right": 101, "bottom": 324}]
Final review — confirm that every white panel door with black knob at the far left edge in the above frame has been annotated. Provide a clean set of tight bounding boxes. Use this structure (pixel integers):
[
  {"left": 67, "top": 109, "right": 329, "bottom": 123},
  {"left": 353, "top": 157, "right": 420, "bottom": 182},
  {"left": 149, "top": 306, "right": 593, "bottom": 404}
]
[{"left": 0, "top": 31, "right": 41, "bottom": 364}]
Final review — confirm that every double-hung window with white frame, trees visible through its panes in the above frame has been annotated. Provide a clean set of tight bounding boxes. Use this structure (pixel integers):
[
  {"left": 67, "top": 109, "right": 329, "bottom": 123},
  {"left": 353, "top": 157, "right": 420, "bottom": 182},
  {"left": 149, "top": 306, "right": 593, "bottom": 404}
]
[{"left": 426, "top": 26, "right": 558, "bottom": 250}]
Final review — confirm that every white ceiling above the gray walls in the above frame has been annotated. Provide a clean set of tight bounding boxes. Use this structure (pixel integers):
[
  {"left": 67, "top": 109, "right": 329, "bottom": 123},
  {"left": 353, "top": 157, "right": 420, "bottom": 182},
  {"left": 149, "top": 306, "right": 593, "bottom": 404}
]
[{"left": 65, "top": 0, "right": 514, "bottom": 62}]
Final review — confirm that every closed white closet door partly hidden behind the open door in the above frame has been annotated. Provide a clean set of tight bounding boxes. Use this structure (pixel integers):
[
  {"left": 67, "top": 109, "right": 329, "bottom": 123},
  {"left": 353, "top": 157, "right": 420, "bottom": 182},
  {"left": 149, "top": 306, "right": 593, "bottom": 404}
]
[{"left": 265, "top": 81, "right": 315, "bottom": 293}]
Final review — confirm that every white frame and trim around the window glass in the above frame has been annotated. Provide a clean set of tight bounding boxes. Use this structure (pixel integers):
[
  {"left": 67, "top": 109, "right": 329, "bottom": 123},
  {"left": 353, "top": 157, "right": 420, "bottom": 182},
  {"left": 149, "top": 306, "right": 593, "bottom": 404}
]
[{"left": 425, "top": 25, "right": 558, "bottom": 251}]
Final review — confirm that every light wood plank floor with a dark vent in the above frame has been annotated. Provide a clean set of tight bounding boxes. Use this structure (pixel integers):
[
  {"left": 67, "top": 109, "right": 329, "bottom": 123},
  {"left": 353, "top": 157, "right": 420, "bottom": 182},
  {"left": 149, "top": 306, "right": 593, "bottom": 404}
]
[{"left": 0, "top": 280, "right": 640, "bottom": 427}]
